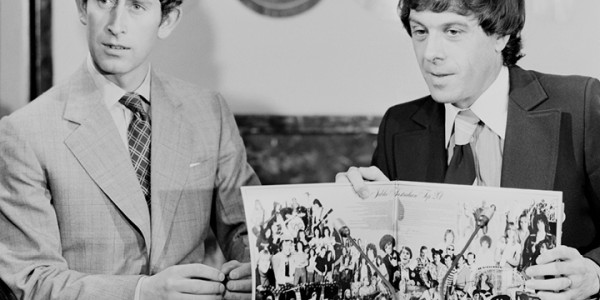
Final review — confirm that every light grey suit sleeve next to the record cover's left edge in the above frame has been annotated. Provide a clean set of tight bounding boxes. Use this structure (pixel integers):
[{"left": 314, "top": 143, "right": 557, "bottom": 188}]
[{"left": 211, "top": 94, "right": 260, "bottom": 262}]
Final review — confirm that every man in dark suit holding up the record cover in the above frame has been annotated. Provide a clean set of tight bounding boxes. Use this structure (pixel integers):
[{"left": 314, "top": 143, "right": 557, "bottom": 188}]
[{"left": 336, "top": 0, "right": 600, "bottom": 299}]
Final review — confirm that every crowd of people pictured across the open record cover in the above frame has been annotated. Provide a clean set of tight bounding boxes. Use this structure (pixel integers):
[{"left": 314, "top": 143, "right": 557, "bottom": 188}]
[{"left": 252, "top": 198, "right": 556, "bottom": 300}]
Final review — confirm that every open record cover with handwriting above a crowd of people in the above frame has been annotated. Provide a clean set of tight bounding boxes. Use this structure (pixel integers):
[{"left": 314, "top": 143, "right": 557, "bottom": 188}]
[{"left": 242, "top": 181, "right": 563, "bottom": 300}]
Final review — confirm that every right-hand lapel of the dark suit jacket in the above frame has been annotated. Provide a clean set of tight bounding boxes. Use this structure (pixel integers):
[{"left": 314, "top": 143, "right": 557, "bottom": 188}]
[{"left": 501, "top": 67, "right": 561, "bottom": 189}]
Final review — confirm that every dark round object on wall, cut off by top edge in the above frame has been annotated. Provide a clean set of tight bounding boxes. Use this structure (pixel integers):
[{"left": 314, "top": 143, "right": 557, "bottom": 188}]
[{"left": 240, "top": 0, "right": 320, "bottom": 17}]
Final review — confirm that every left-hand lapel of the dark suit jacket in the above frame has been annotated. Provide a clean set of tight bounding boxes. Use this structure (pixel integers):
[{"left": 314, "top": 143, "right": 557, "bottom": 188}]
[{"left": 394, "top": 99, "right": 447, "bottom": 182}]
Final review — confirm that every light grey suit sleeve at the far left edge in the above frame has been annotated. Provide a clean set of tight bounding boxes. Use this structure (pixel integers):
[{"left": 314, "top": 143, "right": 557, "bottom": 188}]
[{"left": 0, "top": 117, "right": 140, "bottom": 299}]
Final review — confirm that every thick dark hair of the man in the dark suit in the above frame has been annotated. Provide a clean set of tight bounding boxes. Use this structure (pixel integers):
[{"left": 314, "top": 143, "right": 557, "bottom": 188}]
[{"left": 398, "top": 0, "right": 525, "bottom": 66}]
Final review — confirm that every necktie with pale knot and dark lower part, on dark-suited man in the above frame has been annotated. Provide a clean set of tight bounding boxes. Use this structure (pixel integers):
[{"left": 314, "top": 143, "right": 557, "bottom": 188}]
[{"left": 444, "top": 109, "right": 479, "bottom": 185}]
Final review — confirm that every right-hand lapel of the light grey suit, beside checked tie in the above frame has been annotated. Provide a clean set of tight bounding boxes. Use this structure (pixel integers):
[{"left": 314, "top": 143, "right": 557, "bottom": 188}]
[{"left": 150, "top": 72, "right": 195, "bottom": 265}]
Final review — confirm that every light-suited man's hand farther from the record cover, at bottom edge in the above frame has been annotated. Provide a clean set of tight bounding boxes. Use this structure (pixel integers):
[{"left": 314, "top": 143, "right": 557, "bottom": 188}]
[{"left": 140, "top": 264, "right": 225, "bottom": 300}]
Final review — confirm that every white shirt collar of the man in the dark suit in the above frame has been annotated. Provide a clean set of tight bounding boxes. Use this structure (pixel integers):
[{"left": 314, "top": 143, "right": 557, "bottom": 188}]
[{"left": 444, "top": 66, "right": 509, "bottom": 147}]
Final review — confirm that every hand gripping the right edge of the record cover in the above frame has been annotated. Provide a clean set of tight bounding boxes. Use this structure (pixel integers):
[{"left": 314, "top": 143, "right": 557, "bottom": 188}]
[{"left": 525, "top": 246, "right": 600, "bottom": 299}]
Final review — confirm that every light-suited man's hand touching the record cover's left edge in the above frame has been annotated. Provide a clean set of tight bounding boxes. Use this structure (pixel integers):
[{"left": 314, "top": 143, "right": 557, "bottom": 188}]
[{"left": 221, "top": 260, "right": 252, "bottom": 299}]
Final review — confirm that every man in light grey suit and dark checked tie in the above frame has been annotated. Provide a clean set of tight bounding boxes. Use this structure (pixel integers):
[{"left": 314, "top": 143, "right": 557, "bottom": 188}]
[{"left": 0, "top": 0, "right": 259, "bottom": 300}]
